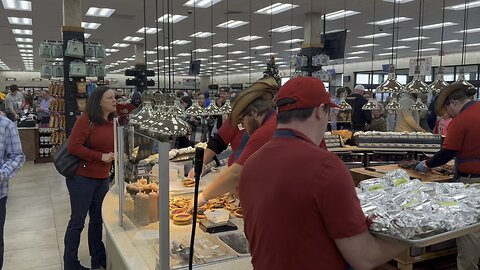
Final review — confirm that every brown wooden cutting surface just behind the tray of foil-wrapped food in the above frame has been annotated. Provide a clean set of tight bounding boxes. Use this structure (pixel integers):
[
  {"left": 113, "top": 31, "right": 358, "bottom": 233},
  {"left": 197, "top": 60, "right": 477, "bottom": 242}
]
[{"left": 350, "top": 164, "right": 453, "bottom": 186}]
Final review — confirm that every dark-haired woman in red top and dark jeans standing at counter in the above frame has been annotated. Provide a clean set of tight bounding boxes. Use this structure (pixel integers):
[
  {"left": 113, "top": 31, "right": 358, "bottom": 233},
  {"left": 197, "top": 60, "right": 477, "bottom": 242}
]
[{"left": 63, "top": 86, "right": 117, "bottom": 270}]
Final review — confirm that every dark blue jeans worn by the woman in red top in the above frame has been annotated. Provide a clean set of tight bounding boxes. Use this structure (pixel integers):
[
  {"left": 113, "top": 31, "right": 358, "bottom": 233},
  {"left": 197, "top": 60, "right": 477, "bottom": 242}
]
[{"left": 63, "top": 176, "right": 108, "bottom": 270}]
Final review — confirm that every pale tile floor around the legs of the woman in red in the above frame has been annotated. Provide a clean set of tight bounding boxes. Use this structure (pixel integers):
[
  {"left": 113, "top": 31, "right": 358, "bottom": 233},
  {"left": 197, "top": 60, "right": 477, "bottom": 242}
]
[{"left": 3, "top": 162, "right": 90, "bottom": 270}]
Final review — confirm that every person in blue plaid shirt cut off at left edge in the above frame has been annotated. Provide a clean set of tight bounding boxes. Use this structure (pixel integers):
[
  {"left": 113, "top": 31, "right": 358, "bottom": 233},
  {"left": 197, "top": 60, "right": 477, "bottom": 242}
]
[{"left": 0, "top": 113, "right": 25, "bottom": 269}]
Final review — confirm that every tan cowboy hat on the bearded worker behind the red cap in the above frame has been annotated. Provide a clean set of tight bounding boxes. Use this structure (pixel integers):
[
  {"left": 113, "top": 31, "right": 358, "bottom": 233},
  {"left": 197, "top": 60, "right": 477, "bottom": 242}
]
[{"left": 230, "top": 77, "right": 278, "bottom": 127}]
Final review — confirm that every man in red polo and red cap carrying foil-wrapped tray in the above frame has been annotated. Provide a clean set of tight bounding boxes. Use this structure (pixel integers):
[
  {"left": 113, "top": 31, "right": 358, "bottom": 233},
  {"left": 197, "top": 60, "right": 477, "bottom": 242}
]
[{"left": 239, "top": 77, "right": 406, "bottom": 270}]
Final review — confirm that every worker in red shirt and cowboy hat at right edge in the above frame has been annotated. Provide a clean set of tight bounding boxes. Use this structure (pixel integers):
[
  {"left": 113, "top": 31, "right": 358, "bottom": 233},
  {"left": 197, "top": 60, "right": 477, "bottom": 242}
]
[{"left": 416, "top": 84, "right": 480, "bottom": 270}]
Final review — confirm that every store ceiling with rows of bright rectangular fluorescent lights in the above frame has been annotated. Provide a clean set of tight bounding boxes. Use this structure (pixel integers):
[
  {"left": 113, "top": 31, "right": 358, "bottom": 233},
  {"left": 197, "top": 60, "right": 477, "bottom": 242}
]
[{"left": 0, "top": 0, "right": 480, "bottom": 75}]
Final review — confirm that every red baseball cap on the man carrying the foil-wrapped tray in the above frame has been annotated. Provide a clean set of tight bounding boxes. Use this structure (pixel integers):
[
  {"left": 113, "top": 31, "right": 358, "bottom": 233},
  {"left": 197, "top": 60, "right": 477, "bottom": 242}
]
[{"left": 275, "top": 77, "right": 338, "bottom": 112}]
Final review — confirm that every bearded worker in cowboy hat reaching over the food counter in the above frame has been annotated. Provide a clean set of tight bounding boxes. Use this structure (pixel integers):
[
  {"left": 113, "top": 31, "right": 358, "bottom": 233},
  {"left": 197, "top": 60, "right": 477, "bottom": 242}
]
[{"left": 194, "top": 77, "right": 277, "bottom": 206}]
